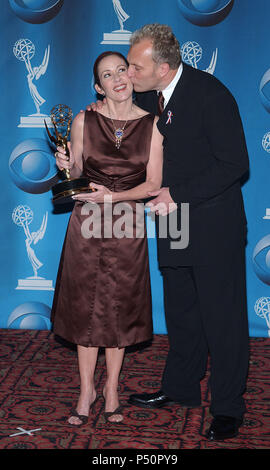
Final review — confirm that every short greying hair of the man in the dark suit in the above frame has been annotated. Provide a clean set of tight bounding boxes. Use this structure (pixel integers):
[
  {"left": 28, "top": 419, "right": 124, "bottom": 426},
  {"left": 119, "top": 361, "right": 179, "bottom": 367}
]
[{"left": 130, "top": 23, "right": 181, "bottom": 70}]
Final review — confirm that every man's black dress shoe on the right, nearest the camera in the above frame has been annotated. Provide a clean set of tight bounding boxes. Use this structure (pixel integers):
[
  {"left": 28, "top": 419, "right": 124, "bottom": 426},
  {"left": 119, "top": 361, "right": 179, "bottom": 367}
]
[{"left": 206, "top": 415, "right": 243, "bottom": 441}]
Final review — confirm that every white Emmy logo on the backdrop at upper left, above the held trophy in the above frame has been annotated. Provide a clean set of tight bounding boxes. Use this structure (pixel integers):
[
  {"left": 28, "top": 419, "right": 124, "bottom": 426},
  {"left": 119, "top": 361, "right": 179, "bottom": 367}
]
[{"left": 13, "top": 39, "right": 52, "bottom": 127}]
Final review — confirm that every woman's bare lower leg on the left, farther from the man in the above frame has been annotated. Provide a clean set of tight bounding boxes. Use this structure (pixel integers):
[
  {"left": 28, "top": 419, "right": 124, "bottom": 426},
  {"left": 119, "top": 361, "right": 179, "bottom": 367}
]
[{"left": 68, "top": 346, "right": 98, "bottom": 425}]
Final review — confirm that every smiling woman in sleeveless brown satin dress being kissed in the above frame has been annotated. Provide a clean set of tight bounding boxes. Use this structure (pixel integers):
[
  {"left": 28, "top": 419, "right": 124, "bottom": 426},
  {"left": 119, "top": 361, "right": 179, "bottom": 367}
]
[{"left": 52, "top": 52, "right": 162, "bottom": 426}]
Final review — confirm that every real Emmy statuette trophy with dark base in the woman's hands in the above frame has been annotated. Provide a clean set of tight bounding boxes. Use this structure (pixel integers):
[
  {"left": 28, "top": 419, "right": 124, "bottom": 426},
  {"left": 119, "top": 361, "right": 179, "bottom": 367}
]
[{"left": 44, "top": 104, "right": 92, "bottom": 204}]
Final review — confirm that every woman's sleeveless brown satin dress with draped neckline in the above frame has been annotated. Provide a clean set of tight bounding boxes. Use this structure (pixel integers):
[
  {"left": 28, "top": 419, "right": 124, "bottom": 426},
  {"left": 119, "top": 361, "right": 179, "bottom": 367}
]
[{"left": 51, "top": 111, "right": 154, "bottom": 348}]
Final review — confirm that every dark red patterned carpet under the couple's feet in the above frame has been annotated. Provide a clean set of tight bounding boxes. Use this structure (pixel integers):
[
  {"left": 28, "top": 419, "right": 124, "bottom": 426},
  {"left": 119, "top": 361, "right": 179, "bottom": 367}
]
[{"left": 0, "top": 330, "right": 270, "bottom": 451}]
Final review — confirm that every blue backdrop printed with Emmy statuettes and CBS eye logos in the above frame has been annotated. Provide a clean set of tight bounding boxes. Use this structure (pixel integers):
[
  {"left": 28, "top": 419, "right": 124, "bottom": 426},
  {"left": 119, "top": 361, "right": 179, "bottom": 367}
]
[{"left": 0, "top": 0, "right": 270, "bottom": 336}]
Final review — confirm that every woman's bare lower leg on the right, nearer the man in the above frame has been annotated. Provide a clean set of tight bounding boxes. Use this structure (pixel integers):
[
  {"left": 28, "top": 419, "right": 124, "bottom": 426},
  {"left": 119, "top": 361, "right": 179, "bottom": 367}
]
[{"left": 103, "top": 348, "right": 125, "bottom": 422}]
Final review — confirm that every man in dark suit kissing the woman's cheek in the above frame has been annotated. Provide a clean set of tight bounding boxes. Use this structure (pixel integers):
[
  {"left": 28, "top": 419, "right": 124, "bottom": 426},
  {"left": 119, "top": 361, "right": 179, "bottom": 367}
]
[{"left": 128, "top": 24, "right": 249, "bottom": 440}]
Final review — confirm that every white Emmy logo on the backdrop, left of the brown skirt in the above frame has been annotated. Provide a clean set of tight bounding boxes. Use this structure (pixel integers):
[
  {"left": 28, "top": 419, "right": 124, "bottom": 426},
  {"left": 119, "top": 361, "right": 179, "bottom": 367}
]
[{"left": 12, "top": 205, "right": 54, "bottom": 290}]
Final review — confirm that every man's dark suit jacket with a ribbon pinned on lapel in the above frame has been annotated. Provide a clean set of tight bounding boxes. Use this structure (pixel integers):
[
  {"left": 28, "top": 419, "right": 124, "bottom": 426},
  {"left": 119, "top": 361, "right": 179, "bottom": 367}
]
[{"left": 136, "top": 64, "right": 249, "bottom": 266}]
